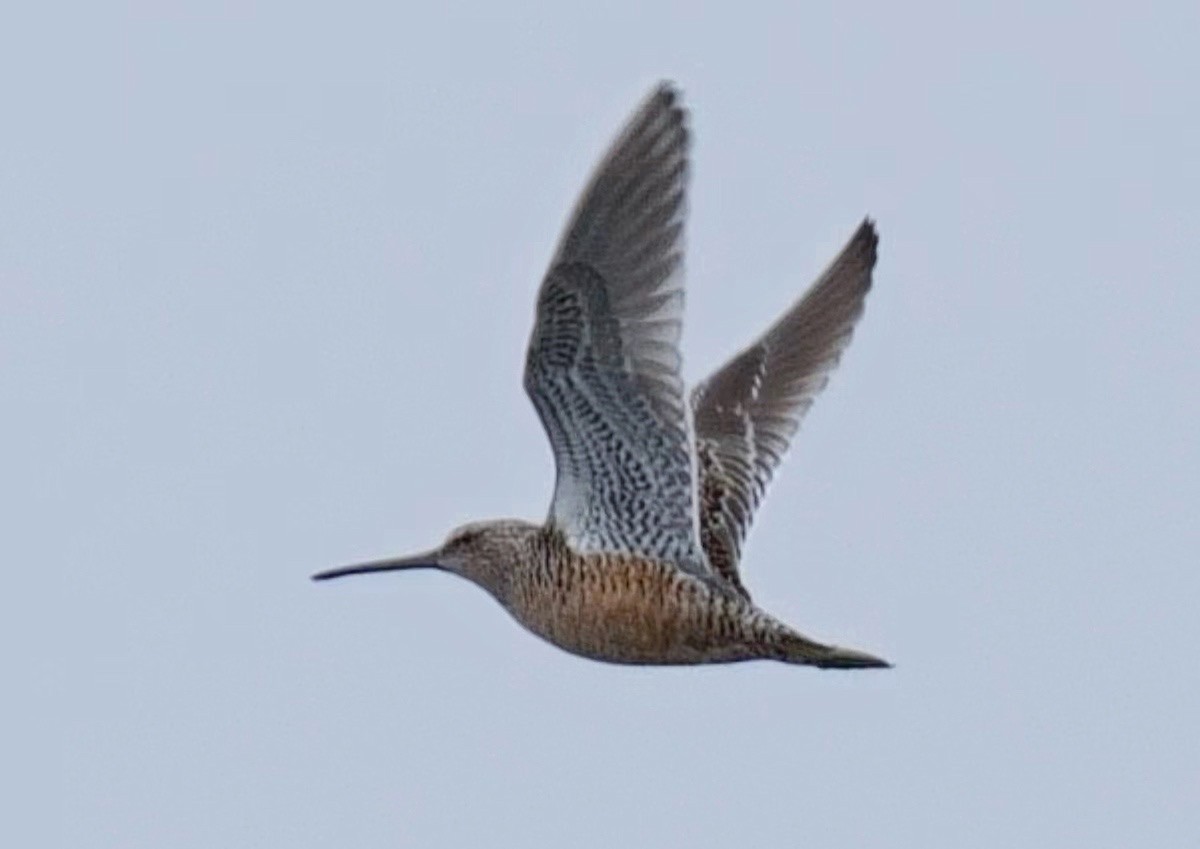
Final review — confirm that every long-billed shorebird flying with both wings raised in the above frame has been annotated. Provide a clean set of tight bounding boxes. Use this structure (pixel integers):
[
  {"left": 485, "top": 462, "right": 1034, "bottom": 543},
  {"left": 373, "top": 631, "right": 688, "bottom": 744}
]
[{"left": 313, "top": 83, "right": 889, "bottom": 668}]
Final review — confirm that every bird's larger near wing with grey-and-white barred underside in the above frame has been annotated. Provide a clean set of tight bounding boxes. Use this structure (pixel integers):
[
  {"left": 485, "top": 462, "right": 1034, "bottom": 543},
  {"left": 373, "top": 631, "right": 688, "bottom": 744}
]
[{"left": 524, "top": 85, "right": 709, "bottom": 574}]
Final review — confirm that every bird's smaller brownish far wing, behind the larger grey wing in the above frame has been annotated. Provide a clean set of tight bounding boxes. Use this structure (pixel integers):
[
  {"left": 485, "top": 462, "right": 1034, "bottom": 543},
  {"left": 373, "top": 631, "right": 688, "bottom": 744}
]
[{"left": 691, "top": 221, "right": 878, "bottom": 598}]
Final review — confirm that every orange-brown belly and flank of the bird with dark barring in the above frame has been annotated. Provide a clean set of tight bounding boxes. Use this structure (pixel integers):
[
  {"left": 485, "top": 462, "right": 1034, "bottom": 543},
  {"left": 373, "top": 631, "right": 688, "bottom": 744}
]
[{"left": 510, "top": 559, "right": 762, "bottom": 664}]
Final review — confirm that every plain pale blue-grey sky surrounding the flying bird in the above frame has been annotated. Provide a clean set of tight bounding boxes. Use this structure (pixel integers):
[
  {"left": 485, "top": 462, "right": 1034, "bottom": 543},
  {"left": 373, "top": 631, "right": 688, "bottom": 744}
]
[{"left": 0, "top": 2, "right": 1200, "bottom": 849}]
